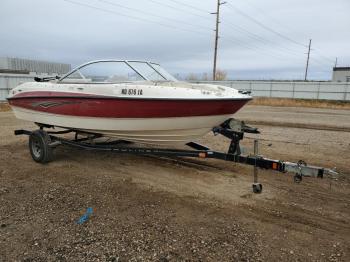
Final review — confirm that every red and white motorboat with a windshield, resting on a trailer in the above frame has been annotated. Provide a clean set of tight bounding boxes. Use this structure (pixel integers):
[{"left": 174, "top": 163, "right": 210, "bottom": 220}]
[{"left": 7, "top": 60, "right": 252, "bottom": 144}]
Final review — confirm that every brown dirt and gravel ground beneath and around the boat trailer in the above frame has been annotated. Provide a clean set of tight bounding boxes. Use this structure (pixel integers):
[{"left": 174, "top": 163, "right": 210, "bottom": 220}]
[{"left": 0, "top": 106, "right": 350, "bottom": 261}]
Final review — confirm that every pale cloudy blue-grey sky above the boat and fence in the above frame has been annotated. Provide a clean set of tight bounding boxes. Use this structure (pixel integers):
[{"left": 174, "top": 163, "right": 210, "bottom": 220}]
[{"left": 0, "top": 0, "right": 350, "bottom": 80}]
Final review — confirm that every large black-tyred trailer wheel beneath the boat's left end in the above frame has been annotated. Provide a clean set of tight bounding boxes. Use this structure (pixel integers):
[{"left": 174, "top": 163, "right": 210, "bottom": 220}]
[{"left": 29, "top": 130, "right": 52, "bottom": 164}]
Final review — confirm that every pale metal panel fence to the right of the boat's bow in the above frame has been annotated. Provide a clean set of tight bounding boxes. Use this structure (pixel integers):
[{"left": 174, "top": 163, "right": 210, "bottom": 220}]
[{"left": 191, "top": 81, "right": 350, "bottom": 101}]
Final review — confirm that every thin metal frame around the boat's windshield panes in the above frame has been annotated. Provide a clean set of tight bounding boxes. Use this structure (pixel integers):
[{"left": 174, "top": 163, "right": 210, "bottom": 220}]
[{"left": 57, "top": 59, "right": 177, "bottom": 84}]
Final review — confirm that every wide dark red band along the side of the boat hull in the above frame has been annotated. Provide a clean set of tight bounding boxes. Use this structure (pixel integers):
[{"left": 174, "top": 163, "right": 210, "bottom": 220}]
[{"left": 9, "top": 92, "right": 249, "bottom": 118}]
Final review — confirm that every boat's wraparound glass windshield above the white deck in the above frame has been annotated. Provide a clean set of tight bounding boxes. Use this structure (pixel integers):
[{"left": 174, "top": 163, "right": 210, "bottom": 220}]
[{"left": 59, "top": 60, "right": 177, "bottom": 83}]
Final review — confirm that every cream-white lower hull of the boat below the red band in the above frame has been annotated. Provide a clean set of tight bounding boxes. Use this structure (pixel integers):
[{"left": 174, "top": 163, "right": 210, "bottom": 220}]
[{"left": 12, "top": 107, "right": 232, "bottom": 144}]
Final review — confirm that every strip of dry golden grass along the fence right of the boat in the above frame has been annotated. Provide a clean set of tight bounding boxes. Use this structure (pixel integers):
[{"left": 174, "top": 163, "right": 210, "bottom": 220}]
[{"left": 249, "top": 97, "right": 350, "bottom": 109}]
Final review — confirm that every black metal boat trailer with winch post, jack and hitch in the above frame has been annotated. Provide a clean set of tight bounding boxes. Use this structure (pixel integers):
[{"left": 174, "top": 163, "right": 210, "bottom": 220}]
[{"left": 14, "top": 118, "right": 338, "bottom": 193}]
